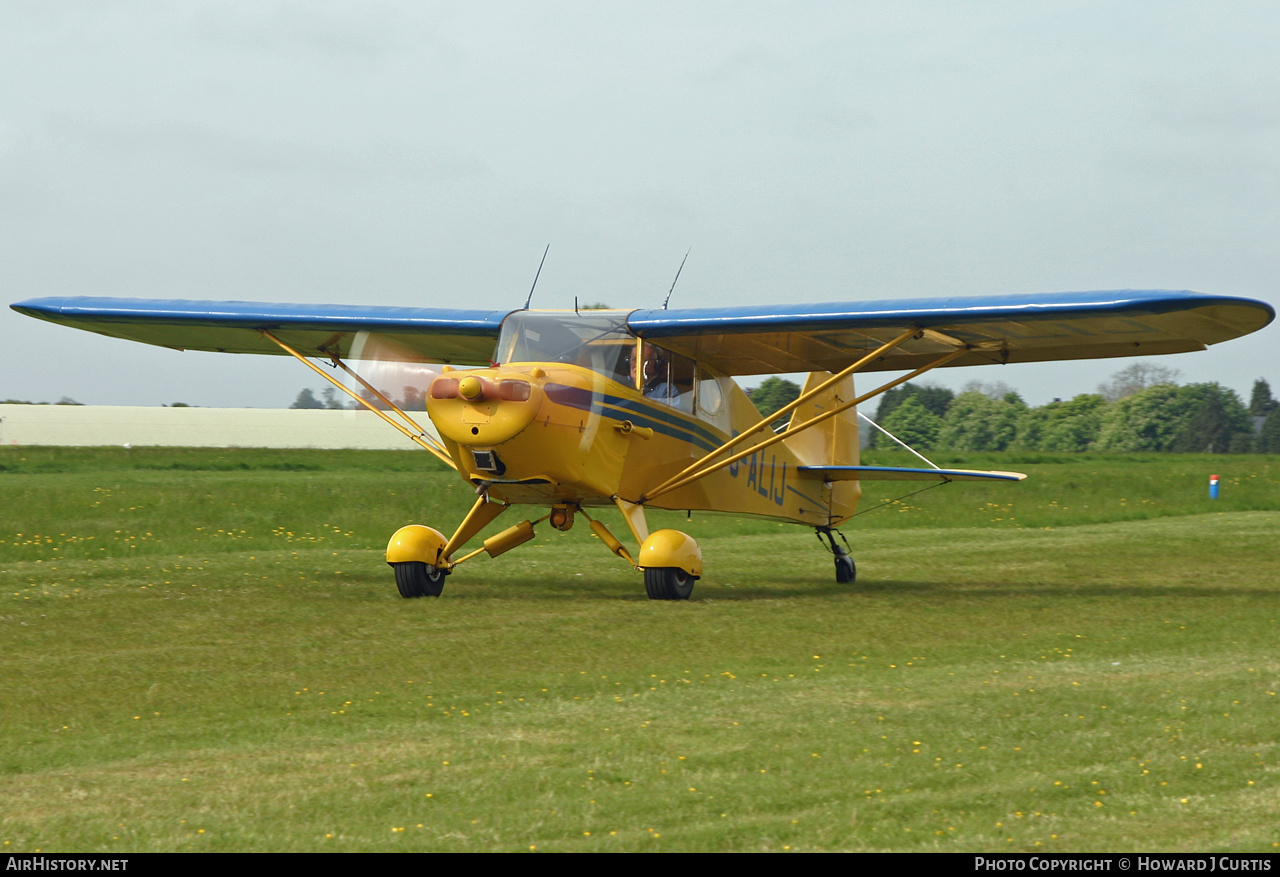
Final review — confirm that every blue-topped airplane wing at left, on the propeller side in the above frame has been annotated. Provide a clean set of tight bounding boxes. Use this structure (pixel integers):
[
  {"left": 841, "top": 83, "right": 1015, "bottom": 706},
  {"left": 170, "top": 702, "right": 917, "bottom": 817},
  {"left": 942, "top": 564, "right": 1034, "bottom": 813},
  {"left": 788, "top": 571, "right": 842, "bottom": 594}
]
[{"left": 12, "top": 297, "right": 508, "bottom": 365}]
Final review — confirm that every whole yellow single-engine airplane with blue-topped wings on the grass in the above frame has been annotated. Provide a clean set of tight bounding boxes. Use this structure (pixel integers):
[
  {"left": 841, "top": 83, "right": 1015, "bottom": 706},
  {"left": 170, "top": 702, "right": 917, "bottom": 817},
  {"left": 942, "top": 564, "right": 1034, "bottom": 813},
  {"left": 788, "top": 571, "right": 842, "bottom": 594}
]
[{"left": 13, "top": 291, "right": 1275, "bottom": 600}]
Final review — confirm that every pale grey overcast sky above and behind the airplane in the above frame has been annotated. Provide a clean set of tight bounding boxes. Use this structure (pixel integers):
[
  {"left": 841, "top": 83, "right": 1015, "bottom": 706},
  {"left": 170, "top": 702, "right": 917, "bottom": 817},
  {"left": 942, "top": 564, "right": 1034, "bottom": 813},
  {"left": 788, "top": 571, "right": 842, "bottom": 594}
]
[{"left": 0, "top": 0, "right": 1280, "bottom": 407}]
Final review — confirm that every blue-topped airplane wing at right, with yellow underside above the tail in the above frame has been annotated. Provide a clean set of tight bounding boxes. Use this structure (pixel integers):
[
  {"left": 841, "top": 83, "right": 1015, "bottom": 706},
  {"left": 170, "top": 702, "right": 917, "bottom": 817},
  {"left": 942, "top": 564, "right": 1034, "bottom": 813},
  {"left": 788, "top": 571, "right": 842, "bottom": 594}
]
[{"left": 627, "top": 289, "right": 1275, "bottom": 375}]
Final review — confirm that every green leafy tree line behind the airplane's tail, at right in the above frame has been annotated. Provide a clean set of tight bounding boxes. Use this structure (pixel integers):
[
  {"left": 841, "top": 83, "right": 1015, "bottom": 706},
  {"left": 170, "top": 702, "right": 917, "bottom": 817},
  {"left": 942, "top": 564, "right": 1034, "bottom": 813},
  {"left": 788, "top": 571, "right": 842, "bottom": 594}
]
[{"left": 748, "top": 364, "right": 1280, "bottom": 453}]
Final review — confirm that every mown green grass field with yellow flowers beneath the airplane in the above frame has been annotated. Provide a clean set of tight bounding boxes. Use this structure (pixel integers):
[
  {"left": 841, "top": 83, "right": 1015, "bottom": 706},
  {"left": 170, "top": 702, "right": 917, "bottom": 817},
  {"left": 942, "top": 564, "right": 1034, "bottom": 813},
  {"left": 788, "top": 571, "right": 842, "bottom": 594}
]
[{"left": 0, "top": 448, "right": 1280, "bottom": 853}]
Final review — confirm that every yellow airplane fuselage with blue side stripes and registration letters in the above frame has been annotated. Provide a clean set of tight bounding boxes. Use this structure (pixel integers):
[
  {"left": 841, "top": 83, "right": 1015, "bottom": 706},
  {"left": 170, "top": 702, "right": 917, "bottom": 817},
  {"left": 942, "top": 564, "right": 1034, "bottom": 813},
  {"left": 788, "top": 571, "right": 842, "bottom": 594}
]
[{"left": 426, "top": 362, "right": 856, "bottom": 526}]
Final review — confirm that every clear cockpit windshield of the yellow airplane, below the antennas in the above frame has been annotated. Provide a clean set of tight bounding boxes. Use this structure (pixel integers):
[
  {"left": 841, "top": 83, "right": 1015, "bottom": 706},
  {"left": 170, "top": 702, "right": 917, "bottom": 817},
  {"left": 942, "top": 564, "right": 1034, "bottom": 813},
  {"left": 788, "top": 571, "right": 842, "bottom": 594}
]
[{"left": 498, "top": 310, "right": 636, "bottom": 384}]
